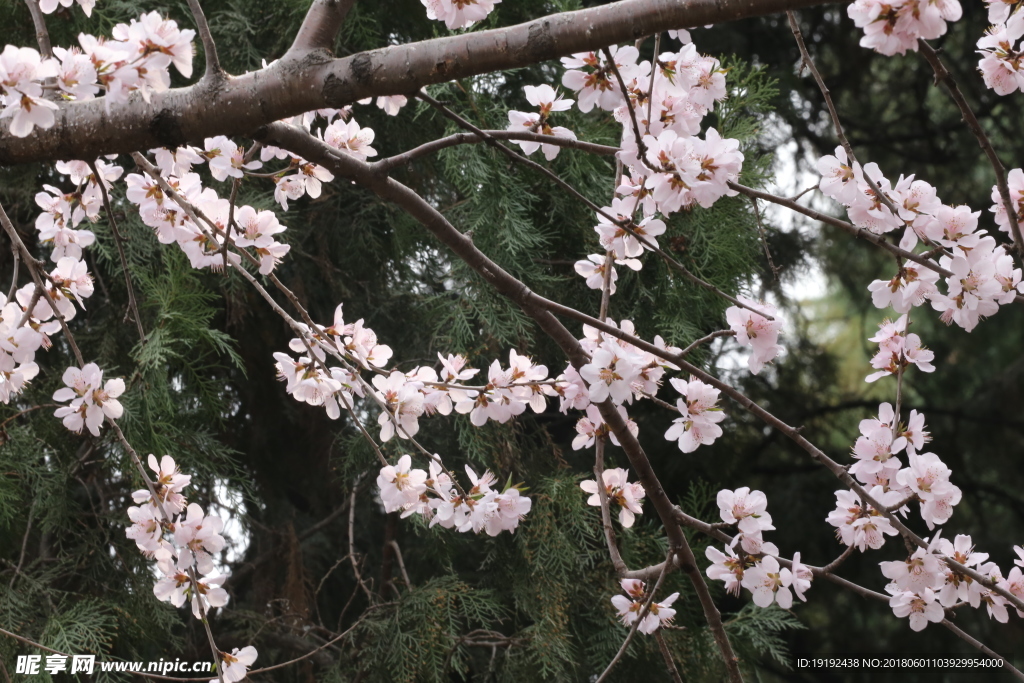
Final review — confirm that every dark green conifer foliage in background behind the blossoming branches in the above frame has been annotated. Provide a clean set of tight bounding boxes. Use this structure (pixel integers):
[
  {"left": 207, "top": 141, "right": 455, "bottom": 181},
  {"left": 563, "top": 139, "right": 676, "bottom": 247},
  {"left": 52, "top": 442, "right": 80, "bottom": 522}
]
[{"left": 0, "top": 0, "right": 937, "bottom": 683}]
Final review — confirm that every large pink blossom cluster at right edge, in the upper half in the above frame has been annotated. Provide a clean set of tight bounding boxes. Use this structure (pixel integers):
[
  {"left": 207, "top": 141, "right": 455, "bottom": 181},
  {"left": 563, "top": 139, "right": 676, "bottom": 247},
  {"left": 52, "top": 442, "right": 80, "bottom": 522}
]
[{"left": 818, "top": 147, "right": 1024, "bottom": 332}]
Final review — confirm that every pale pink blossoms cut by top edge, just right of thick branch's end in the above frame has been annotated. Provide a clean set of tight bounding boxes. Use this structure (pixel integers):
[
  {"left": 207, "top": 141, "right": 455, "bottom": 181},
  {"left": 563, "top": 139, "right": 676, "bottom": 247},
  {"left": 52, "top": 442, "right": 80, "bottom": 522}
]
[{"left": 847, "top": 0, "right": 963, "bottom": 56}]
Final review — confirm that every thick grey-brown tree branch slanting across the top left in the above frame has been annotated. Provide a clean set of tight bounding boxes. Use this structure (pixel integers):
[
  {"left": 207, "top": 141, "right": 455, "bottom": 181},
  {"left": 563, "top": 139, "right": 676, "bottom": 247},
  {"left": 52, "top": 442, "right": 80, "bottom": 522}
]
[{"left": 0, "top": 0, "right": 835, "bottom": 165}]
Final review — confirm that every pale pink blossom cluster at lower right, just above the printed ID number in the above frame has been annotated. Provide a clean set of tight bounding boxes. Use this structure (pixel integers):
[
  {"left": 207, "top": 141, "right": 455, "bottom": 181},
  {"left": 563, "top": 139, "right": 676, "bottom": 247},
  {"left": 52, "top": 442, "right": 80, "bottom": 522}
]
[{"left": 880, "top": 535, "right": 1024, "bottom": 631}]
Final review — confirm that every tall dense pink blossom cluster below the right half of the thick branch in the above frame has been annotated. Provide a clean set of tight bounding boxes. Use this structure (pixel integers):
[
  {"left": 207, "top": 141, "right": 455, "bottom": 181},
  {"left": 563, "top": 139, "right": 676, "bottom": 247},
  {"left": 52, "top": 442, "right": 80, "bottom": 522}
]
[{"left": 557, "top": 38, "right": 743, "bottom": 293}]
